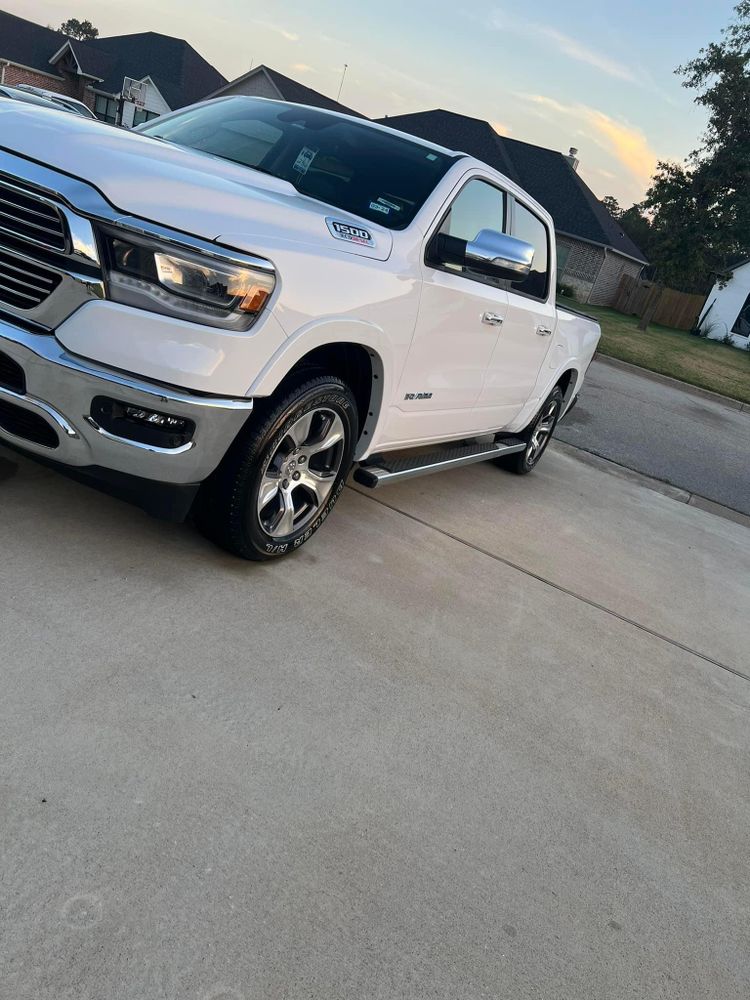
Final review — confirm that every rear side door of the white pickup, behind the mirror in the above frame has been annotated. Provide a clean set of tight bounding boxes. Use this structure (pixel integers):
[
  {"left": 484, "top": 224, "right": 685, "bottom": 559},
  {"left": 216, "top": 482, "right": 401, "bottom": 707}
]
[{"left": 478, "top": 199, "right": 557, "bottom": 412}]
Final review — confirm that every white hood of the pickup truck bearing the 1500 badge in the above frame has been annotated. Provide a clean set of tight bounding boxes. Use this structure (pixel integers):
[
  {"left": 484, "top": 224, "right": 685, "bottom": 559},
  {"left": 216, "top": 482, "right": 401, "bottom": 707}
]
[{"left": 0, "top": 99, "right": 393, "bottom": 260}]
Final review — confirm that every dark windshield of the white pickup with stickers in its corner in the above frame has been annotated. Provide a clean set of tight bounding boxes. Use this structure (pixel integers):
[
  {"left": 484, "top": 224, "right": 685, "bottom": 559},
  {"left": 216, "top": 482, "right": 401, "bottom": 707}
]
[{"left": 138, "top": 97, "right": 456, "bottom": 229}]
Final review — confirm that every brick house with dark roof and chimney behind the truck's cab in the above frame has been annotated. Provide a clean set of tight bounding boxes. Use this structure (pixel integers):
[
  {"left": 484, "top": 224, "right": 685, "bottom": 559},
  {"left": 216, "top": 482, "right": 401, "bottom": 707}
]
[{"left": 380, "top": 111, "right": 648, "bottom": 305}]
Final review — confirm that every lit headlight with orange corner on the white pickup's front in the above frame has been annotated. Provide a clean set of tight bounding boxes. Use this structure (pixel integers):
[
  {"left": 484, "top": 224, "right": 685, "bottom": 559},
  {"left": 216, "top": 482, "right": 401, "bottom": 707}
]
[{"left": 101, "top": 230, "right": 276, "bottom": 330}]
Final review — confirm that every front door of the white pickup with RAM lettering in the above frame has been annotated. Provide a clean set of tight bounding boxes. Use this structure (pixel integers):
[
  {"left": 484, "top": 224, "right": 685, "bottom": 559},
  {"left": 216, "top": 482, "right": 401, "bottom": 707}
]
[{"left": 387, "top": 177, "right": 508, "bottom": 443}]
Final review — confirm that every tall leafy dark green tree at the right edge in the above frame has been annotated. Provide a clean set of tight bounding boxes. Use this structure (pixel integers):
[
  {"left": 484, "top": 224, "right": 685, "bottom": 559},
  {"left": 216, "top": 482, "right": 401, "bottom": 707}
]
[{"left": 644, "top": 0, "right": 750, "bottom": 291}]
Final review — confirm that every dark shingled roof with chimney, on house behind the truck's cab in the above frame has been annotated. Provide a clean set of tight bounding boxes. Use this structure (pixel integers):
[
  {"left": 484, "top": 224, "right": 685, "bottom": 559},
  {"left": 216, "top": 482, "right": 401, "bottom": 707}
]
[{"left": 380, "top": 110, "right": 647, "bottom": 264}]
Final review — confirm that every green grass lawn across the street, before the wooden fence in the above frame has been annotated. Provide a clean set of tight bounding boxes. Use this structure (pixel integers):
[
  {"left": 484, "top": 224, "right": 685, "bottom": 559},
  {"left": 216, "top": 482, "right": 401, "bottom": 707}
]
[{"left": 580, "top": 299, "right": 750, "bottom": 403}]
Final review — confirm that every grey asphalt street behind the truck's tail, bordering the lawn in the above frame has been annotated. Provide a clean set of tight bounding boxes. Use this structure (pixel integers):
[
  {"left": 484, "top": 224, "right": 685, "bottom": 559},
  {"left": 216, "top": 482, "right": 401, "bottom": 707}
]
[{"left": 555, "top": 361, "right": 750, "bottom": 514}]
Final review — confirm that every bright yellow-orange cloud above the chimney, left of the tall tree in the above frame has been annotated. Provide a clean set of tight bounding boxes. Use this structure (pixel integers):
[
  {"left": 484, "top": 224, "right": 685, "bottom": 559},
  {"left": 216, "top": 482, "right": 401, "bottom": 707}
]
[{"left": 516, "top": 94, "right": 658, "bottom": 185}]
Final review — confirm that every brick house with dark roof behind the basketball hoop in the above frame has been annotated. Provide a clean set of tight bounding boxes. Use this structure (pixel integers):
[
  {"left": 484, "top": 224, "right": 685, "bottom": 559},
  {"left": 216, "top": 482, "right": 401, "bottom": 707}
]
[{"left": 0, "top": 10, "right": 227, "bottom": 126}]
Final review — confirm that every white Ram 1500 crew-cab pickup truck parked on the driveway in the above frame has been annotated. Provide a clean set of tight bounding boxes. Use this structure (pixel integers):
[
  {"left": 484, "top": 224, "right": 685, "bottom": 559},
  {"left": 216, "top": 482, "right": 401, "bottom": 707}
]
[{"left": 0, "top": 97, "right": 599, "bottom": 559}]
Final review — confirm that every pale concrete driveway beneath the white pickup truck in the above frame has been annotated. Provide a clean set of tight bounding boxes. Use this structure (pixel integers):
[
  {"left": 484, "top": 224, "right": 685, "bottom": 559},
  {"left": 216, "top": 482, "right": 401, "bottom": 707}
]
[{"left": 0, "top": 449, "right": 750, "bottom": 1000}]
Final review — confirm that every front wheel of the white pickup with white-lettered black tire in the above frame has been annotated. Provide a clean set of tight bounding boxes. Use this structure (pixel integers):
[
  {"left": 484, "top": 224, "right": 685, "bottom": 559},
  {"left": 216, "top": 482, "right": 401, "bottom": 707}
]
[{"left": 196, "top": 375, "right": 357, "bottom": 560}]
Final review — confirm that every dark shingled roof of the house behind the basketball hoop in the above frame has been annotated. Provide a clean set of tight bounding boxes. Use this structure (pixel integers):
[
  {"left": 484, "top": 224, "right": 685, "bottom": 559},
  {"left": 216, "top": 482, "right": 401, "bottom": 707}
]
[{"left": 0, "top": 10, "right": 227, "bottom": 110}]
